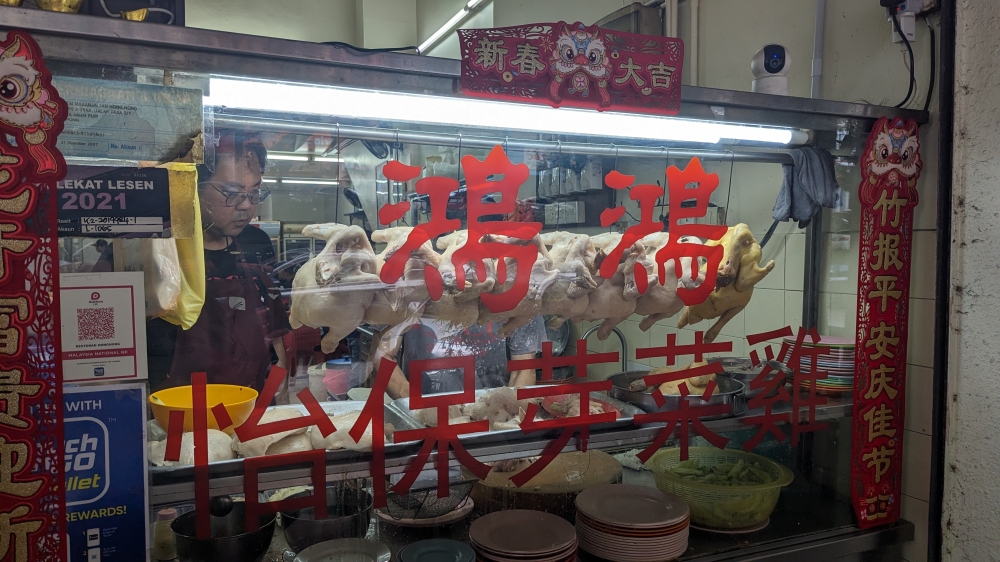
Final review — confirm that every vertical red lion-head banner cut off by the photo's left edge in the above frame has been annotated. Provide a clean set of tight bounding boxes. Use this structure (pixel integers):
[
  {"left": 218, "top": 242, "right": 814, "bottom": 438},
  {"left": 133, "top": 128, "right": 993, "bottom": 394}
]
[{"left": 0, "top": 32, "right": 66, "bottom": 562}]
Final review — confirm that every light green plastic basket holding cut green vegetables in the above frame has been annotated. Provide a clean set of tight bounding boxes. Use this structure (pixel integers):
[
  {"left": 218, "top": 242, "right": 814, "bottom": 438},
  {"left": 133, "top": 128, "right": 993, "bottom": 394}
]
[{"left": 646, "top": 447, "right": 794, "bottom": 530}]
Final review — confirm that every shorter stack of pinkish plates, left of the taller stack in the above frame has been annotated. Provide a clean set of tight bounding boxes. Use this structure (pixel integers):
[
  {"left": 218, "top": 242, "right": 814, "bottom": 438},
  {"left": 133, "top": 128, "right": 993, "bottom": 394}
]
[{"left": 469, "top": 509, "right": 577, "bottom": 562}]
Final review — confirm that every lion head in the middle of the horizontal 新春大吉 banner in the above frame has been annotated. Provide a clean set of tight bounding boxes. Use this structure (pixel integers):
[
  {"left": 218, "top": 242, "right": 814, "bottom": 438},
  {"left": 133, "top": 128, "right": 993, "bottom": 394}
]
[{"left": 549, "top": 25, "right": 611, "bottom": 107}]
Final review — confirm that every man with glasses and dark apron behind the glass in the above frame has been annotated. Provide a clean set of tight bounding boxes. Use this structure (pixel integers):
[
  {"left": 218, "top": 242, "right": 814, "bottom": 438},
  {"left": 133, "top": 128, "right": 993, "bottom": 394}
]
[{"left": 146, "top": 132, "right": 291, "bottom": 392}]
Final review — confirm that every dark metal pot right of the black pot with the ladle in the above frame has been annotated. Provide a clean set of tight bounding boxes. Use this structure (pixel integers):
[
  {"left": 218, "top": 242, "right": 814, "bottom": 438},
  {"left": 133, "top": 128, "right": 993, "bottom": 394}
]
[{"left": 281, "top": 486, "right": 374, "bottom": 553}]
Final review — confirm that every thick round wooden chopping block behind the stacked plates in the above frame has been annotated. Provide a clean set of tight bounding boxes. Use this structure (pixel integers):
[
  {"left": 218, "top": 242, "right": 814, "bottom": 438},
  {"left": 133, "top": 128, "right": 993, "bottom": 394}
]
[{"left": 463, "top": 450, "right": 622, "bottom": 523}]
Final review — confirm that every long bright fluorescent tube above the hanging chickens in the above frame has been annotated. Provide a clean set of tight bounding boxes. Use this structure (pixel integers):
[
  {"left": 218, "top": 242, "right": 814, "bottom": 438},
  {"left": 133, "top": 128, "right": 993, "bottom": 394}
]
[{"left": 204, "top": 77, "right": 803, "bottom": 145}]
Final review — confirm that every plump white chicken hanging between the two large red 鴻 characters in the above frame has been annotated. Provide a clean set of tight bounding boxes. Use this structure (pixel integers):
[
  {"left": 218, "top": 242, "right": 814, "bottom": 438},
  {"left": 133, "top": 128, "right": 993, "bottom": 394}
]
[{"left": 541, "top": 232, "right": 597, "bottom": 328}]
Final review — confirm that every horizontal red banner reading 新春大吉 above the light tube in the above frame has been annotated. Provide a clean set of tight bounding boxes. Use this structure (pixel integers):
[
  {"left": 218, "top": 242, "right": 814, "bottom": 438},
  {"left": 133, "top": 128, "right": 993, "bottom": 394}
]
[{"left": 458, "top": 22, "right": 684, "bottom": 115}]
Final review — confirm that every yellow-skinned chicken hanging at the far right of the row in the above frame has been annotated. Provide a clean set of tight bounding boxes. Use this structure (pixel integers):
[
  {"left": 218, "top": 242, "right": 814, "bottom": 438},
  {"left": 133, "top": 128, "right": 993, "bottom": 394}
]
[{"left": 677, "top": 223, "right": 774, "bottom": 342}]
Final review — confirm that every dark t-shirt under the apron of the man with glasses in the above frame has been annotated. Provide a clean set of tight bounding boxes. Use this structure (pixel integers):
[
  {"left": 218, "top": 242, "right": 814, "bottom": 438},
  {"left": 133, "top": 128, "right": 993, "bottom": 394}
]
[{"left": 146, "top": 226, "right": 291, "bottom": 391}]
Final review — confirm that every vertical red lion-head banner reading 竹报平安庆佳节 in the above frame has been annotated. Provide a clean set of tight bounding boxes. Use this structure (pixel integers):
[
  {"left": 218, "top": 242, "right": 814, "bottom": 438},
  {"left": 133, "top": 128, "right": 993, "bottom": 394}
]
[{"left": 851, "top": 117, "right": 923, "bottom": 528}]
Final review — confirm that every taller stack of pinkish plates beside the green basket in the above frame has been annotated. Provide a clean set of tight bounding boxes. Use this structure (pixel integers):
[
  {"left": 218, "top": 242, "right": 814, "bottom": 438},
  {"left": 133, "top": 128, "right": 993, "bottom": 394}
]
[{"left": 576, "top": 484, "right": 691, "bottom": 562}]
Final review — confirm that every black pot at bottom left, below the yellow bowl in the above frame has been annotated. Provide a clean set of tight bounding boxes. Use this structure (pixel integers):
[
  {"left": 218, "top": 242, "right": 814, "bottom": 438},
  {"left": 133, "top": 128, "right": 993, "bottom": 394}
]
[{"left": 170, "top": 502, "right": 275, "bottom": 562}]
